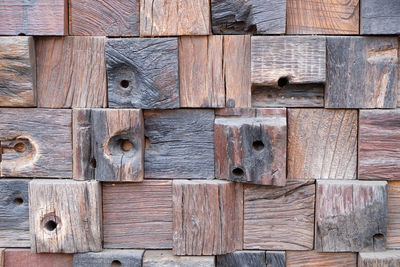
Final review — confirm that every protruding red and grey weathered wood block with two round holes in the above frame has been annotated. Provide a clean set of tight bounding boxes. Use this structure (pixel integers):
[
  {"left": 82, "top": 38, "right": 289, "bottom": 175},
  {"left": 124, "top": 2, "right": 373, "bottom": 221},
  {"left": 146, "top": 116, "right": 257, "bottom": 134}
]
[{"left": 214, "top": 109, "right": 287, "bottom": 186}]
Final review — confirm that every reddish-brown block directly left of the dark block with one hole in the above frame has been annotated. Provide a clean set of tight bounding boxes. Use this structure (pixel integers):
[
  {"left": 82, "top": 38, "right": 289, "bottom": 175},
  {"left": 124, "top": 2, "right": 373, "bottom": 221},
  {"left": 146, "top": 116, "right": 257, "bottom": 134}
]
[{"left": 35, "top": 36, "right": 107, "bottom": 108}]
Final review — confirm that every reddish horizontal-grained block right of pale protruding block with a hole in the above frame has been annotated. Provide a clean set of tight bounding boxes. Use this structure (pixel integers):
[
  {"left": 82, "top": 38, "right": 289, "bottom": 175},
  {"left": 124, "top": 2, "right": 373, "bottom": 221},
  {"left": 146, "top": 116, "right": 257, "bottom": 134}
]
[{"left": 103, "top": 180, "right": 172, "bottom": 249}]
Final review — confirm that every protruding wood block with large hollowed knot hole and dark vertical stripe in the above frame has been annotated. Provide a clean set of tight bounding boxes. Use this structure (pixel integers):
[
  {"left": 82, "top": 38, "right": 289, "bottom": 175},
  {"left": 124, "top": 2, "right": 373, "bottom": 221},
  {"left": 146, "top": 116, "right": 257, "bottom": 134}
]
[{"left": 73, "top": 109, "right": 144, "bottom": 182}]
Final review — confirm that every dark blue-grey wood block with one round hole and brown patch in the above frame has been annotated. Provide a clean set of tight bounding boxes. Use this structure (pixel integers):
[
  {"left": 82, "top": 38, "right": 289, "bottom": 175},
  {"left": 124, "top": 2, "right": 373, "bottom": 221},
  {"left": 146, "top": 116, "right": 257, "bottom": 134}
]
[{"left": 106, "top": 38, "right": 179, "bottom": 109}]
